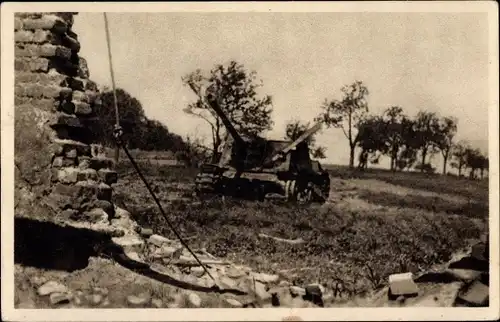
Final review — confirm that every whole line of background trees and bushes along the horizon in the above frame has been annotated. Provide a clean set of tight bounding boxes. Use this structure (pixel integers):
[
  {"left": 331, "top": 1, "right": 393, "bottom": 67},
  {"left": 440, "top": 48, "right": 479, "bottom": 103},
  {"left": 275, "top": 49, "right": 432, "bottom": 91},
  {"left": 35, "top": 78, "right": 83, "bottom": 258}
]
[{"left": 93, "top": 61, "right": 488, "bottom": 177}]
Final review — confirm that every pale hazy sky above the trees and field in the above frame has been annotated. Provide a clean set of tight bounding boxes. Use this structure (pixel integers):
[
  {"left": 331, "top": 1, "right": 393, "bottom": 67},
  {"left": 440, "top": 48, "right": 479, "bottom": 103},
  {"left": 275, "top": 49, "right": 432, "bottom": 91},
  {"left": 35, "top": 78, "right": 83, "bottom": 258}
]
[{"left": 73, "top": 12, "right": 489, "bottom": 169}]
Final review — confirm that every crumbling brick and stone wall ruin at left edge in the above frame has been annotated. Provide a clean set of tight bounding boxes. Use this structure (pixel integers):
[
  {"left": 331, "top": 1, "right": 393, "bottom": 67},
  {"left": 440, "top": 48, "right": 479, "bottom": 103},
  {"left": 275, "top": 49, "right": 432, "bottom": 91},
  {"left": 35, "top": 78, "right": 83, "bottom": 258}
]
[{"left": 15, "top": 12, "right": 117, "bottom": 222}]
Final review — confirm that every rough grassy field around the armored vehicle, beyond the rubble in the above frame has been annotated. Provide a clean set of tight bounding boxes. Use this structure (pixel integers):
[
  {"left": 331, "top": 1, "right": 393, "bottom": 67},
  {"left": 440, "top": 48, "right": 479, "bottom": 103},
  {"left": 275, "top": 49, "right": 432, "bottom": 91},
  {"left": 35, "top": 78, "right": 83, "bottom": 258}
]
[{"left": 110, "top": 161, "right": 488, "bottom": 294}]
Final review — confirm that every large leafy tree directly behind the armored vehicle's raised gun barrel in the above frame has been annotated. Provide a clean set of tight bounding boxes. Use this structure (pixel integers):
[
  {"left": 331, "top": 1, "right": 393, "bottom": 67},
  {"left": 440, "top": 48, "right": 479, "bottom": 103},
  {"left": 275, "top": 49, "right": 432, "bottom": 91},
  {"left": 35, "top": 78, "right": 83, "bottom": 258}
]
[{"left": 182, "top": 61, "right": 273, "bottom": 162}]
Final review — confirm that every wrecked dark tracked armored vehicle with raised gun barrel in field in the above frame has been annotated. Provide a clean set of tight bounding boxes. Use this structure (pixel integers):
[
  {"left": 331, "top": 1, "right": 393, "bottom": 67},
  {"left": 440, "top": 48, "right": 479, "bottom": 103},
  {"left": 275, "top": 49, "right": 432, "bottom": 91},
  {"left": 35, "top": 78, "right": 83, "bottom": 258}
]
[{"left": 190, "top": 89, "right": 330, "bottom": 203}]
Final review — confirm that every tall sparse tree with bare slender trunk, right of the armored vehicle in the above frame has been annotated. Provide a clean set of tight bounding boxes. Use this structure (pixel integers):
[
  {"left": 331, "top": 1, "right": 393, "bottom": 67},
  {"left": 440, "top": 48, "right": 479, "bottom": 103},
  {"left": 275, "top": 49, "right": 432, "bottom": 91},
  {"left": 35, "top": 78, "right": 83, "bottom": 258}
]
[{"left": 317, "top": 81, "right": 369, "bottom": 168}]
